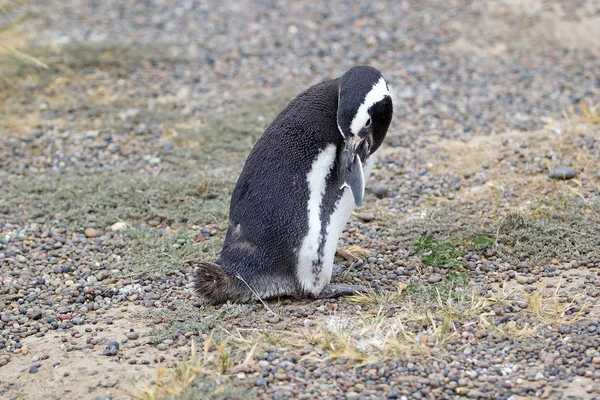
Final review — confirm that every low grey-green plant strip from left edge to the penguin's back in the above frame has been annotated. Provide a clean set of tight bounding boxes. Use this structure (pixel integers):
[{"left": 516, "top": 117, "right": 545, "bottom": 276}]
[{"left": 0, "top": 172, "right": 232, "bottom": 227}]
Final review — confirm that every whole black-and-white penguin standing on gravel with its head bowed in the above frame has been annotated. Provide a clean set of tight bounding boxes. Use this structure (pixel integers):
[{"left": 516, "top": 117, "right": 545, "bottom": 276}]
[{"left": 194, "top": 66, "right": 393, "bottom": 303}]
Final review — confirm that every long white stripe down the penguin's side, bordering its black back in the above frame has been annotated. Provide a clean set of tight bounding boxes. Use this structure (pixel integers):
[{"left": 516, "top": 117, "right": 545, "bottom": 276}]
[{"left": 296, "top": 144, "right": 336, "bottom": 294}]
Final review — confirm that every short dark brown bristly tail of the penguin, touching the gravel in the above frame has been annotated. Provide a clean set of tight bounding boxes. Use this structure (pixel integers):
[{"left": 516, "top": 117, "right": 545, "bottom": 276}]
[{"left": 194, "top": 261, "right": 245, "bottom": 304}]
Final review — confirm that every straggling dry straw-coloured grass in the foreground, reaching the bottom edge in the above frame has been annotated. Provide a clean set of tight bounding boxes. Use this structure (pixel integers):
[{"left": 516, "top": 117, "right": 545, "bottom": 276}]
[{"left": 135, "top": 274, "right": 587, "bottom": 399}]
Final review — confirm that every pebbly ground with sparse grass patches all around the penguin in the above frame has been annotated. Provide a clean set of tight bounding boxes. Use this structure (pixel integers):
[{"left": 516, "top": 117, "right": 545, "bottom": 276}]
[{"left": 0, "top": 0, "right": 600, "bottom": 399}]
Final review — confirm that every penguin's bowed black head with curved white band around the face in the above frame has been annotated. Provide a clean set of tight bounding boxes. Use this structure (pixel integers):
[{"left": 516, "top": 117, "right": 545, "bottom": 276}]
[{"left": 337, "top": 66, "right": 393, "bottom": 162}]
